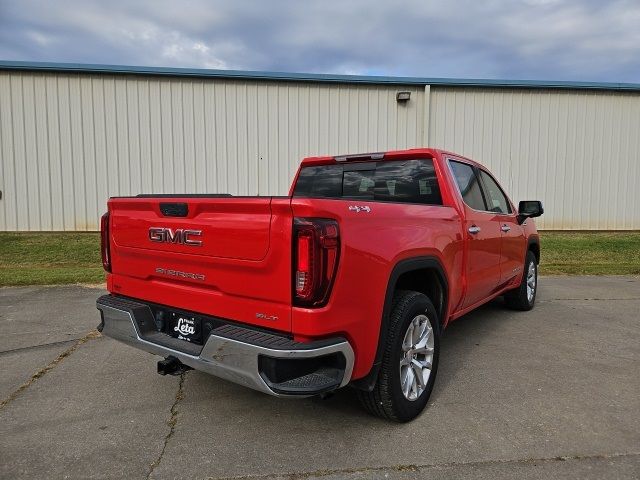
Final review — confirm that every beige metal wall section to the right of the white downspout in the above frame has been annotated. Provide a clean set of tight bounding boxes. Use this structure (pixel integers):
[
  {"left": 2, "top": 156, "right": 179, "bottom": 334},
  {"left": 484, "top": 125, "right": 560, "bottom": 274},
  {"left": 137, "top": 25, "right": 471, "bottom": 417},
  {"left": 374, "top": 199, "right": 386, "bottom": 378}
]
[{"left": 428, "top": 86, "right": 640, "bottom": 230}]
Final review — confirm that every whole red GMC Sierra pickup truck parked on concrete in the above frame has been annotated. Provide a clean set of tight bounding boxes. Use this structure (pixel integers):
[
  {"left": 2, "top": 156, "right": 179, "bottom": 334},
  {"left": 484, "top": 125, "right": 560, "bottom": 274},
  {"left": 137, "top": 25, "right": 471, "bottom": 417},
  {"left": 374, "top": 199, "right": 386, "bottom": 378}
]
[{"left": 97, "top": 148, "right": 543, "bottom": 421}]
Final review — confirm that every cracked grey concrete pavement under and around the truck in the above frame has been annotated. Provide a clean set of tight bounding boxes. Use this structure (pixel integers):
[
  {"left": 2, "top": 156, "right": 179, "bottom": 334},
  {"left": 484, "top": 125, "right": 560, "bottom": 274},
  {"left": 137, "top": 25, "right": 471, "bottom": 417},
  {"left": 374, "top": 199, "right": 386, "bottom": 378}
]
[{"left": 0, "top": 277, "right": 640, "bottom": 479}]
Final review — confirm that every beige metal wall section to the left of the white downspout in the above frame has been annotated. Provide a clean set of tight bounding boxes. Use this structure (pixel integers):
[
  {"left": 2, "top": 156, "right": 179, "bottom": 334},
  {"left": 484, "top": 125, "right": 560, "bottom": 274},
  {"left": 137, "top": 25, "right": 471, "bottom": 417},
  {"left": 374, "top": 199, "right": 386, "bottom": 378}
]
[{"left": 0, "top": 72, "right": 424, "bottom": 231}]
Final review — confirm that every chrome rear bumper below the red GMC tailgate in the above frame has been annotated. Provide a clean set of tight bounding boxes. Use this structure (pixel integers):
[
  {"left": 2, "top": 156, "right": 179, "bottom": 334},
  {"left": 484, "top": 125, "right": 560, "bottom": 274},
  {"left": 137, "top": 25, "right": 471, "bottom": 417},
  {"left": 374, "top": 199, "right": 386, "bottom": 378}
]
[{"left": 96, "top": 295, "right": 354, "bottom": 397}]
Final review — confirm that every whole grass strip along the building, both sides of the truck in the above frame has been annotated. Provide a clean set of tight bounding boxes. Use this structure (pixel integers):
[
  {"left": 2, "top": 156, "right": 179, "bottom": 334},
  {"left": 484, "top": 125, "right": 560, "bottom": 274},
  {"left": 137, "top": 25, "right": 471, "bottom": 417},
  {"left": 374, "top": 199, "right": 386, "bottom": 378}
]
[{"left": 0, "top": 232, "right": 640, "bottom": 286}]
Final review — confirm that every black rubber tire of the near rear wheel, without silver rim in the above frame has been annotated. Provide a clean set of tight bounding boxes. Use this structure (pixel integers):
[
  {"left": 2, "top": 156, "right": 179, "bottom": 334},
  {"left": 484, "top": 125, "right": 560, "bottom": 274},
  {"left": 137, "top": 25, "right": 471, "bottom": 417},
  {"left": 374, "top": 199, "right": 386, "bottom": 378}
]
[{"left": 358, "top": 290, "right": 440, "bottom": 422}]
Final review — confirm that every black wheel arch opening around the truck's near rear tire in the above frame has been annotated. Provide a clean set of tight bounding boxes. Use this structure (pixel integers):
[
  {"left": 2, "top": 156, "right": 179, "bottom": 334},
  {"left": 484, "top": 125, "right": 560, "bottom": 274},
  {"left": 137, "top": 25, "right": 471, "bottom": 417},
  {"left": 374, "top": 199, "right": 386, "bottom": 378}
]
[{"left": 352, "top": 256, "right": 449, "bottom": 391}]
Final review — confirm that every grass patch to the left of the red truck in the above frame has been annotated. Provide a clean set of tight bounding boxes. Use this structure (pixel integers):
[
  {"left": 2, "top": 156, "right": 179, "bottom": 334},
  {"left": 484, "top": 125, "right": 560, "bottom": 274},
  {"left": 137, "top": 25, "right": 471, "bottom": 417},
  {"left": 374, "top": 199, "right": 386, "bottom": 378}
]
[{"left": 0, "top": 232, "right": 104, "bottom": 286}]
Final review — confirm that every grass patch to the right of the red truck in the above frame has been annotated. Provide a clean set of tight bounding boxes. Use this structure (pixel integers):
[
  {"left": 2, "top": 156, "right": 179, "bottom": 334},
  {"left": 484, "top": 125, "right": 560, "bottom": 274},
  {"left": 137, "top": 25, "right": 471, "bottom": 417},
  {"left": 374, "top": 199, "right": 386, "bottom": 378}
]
[{"left": 540, "top": 232, "right": 640, "bottom": 275}]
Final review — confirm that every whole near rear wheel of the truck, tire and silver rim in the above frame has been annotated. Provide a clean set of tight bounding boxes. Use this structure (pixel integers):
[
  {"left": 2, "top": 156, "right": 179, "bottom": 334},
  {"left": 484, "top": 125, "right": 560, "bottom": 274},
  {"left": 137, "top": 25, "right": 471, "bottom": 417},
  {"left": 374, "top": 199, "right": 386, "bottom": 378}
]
[{"left": 358, "top": 290, "right": 440, "bottom": 422}]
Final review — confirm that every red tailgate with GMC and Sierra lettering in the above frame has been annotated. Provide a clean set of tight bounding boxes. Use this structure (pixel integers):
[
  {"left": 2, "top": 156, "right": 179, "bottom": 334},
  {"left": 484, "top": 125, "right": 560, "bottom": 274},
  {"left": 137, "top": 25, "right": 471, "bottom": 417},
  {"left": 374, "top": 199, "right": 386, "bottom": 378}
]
[{"left": 109, "top": 197, "right": 292, "bottom": 331}]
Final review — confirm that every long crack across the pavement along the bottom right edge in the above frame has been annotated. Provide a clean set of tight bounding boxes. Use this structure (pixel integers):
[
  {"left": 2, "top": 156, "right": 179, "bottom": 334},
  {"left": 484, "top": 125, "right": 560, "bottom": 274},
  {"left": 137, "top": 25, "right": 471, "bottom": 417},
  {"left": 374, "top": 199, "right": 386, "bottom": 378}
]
[{"left": 207, "top": 452, "right": 640, "bottom": 480}]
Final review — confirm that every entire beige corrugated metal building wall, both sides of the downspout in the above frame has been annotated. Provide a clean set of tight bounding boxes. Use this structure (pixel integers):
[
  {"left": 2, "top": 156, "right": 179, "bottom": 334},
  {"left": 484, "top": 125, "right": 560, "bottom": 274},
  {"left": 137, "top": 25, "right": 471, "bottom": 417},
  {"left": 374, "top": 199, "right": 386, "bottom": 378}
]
[{"left": 0, "top": 71, "right": 640, "bottom": 230}]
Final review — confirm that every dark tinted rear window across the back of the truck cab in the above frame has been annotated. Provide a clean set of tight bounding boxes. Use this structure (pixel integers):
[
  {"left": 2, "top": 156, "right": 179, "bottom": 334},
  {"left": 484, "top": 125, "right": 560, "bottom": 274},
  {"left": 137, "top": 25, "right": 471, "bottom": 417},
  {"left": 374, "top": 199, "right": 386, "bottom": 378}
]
[{"left": 293, "top": 159, "right": 442, "bottom": 205}]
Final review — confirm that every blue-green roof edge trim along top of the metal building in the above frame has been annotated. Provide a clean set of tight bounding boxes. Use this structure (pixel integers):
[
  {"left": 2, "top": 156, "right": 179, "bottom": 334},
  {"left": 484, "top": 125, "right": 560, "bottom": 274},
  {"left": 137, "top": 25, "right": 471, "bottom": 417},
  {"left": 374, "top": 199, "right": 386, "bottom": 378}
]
[{"left": 0, "top": 60, "right": 640, "bottom": 91}]
